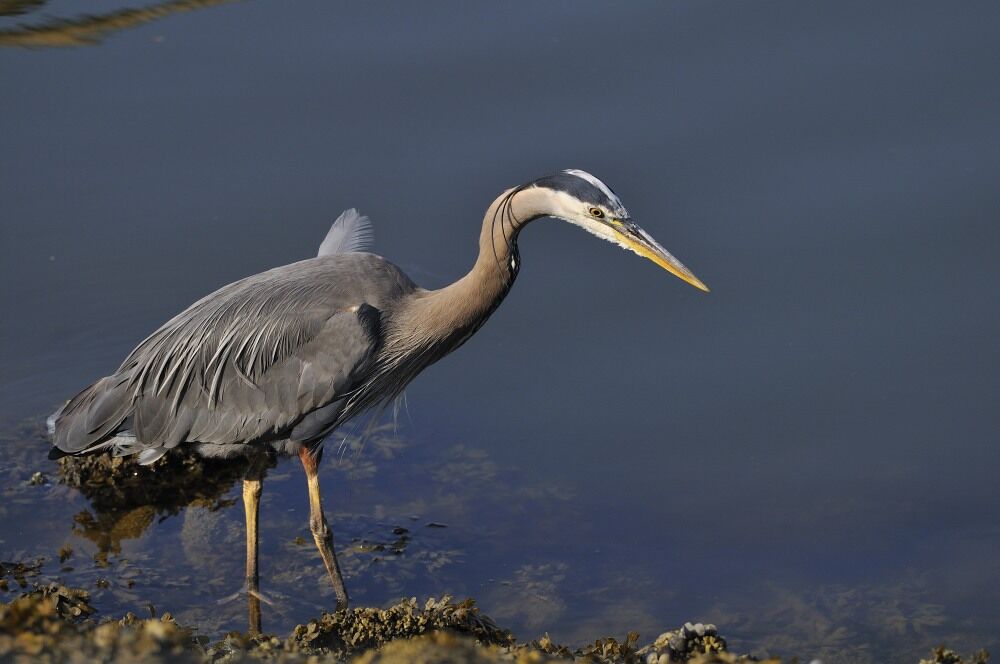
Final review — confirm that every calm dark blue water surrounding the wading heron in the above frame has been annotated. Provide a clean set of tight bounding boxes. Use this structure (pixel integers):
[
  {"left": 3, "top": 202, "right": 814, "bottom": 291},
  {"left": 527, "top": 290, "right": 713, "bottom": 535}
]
[{"left": 0, "top": 0, "right": 1000, "bottom": 662}]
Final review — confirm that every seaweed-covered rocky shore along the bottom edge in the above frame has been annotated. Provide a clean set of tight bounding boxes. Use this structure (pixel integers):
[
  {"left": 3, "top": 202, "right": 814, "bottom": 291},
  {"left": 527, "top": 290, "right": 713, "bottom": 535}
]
[{"left": 0, "top": 580, "right": 989, "bottom": 664}]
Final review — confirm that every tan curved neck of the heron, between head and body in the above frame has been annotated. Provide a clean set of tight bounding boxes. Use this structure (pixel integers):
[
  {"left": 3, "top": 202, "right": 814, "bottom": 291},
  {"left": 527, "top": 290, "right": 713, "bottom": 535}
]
[{"left": 397, "top": 187, "right": 545, "bottom": 352}]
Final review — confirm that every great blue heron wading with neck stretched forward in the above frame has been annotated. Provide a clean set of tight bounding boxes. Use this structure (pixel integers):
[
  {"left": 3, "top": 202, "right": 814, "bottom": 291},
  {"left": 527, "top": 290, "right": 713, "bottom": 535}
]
[{"left": 49, "top": 170, "right": 708, "bottom": 631}]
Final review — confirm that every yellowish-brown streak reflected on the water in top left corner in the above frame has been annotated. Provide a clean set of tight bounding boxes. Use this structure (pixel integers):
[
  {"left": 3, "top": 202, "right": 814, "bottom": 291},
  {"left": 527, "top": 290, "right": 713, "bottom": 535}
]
[{"left": 0, "top": 0, "right": 236, "bottom": 47}]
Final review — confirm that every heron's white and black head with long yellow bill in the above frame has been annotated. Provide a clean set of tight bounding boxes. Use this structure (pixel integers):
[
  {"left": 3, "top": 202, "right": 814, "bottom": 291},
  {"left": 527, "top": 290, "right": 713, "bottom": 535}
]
[{"left": 525, "top": 169, "right": 708, "bottom": 291}]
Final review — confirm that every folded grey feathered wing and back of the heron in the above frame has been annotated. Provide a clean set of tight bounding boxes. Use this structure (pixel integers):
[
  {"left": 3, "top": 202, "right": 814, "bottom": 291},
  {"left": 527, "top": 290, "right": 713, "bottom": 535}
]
[{"left": 53, "top": 254, "right": 414, "bottom": 458}]
